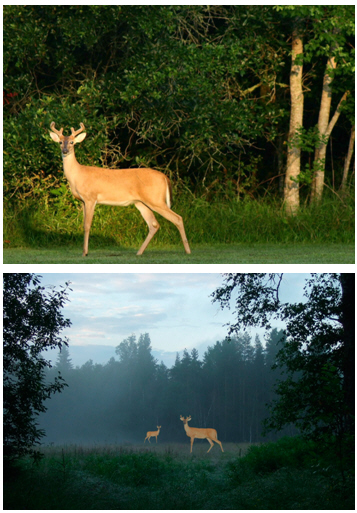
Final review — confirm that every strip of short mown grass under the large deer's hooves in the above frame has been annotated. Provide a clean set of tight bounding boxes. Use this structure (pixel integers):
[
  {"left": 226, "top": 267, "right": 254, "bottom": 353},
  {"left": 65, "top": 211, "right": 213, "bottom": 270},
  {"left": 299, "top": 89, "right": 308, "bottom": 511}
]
[{"left": 3, "top": 243, "right": 355, "bottom": 265}]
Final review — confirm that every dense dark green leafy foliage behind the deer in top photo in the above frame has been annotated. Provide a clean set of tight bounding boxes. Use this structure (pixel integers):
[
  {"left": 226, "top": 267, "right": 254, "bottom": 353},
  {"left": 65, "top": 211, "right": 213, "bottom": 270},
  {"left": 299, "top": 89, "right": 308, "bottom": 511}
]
[{"left": 4, "top": 5, "right": 354, "bottom": 203}]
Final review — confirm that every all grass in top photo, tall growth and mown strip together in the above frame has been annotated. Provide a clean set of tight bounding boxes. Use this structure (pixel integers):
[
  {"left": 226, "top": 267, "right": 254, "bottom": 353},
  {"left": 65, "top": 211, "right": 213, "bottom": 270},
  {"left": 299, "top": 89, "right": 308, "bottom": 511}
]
[{"left": 4, "top": 187, "right": 355, "bottom": 264}]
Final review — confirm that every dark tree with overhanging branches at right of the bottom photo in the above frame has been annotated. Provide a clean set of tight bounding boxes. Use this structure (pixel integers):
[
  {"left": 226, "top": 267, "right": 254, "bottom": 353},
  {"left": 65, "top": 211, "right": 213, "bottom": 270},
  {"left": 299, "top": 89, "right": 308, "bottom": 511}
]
[{"left": 212, "top": 273, "right": 354, "bottom": 440}]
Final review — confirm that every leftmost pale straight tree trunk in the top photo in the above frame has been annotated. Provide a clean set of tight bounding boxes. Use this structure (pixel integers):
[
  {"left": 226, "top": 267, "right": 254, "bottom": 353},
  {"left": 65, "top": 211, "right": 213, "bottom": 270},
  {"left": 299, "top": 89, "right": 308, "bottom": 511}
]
[{"left": 284, "top": 29, "right": 304, "bottom": 214}]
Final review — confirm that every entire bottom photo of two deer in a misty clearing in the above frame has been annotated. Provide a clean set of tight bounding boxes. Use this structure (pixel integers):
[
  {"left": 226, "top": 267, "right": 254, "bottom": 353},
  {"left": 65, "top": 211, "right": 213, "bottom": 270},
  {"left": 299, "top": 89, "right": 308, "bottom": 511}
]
[{"left": 3, "top": 272, "right": 355, "bottom": 510}]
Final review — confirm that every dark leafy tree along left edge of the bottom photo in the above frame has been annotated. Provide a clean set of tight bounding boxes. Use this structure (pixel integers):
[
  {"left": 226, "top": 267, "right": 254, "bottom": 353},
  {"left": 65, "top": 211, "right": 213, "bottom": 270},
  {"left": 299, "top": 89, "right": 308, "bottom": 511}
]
[{"left": 3, "top": 273, "right": 71, "bottom": 461}]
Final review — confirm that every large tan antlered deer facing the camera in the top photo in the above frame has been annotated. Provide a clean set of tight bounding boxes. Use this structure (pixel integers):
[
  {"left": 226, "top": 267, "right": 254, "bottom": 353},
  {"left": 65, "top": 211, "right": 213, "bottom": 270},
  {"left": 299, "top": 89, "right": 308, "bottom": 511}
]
[{"left": 50, "top": 121, "right": 191, "bottom": 256}]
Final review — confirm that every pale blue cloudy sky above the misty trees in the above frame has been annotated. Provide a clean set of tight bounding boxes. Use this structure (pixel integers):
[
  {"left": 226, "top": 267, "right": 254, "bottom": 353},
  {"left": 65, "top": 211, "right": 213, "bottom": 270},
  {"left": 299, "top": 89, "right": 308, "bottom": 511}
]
[{"left": 40, "top": 272, "right": 308, "bottom": 367}]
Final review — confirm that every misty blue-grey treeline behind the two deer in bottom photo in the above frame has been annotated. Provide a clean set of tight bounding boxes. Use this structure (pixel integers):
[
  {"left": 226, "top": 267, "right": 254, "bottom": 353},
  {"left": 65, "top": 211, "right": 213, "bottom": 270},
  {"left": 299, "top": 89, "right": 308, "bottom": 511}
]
[{"left": 39, "top": 329, "right": 296, "bottom": 443}]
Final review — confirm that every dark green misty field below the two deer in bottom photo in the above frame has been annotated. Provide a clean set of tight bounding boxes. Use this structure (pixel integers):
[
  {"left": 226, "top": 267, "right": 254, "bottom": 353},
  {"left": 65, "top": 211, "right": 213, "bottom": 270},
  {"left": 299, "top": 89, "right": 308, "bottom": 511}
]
[{"left": 4, "top": 438, "right": 354, "bottom": 510}]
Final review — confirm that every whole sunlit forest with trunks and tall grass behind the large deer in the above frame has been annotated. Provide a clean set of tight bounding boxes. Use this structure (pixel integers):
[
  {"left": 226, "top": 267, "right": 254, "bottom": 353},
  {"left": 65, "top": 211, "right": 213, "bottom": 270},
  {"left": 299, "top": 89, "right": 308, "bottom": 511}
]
[{"left": 3, "top": 5, "right": 355, "bottom": 257}]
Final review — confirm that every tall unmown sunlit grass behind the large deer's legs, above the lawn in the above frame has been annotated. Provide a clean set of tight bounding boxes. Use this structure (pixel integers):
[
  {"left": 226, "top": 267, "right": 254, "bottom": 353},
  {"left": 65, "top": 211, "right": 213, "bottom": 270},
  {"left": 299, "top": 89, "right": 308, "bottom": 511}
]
[{"left": 4, "top": 186, "right": 354, "bottom": 249}]
